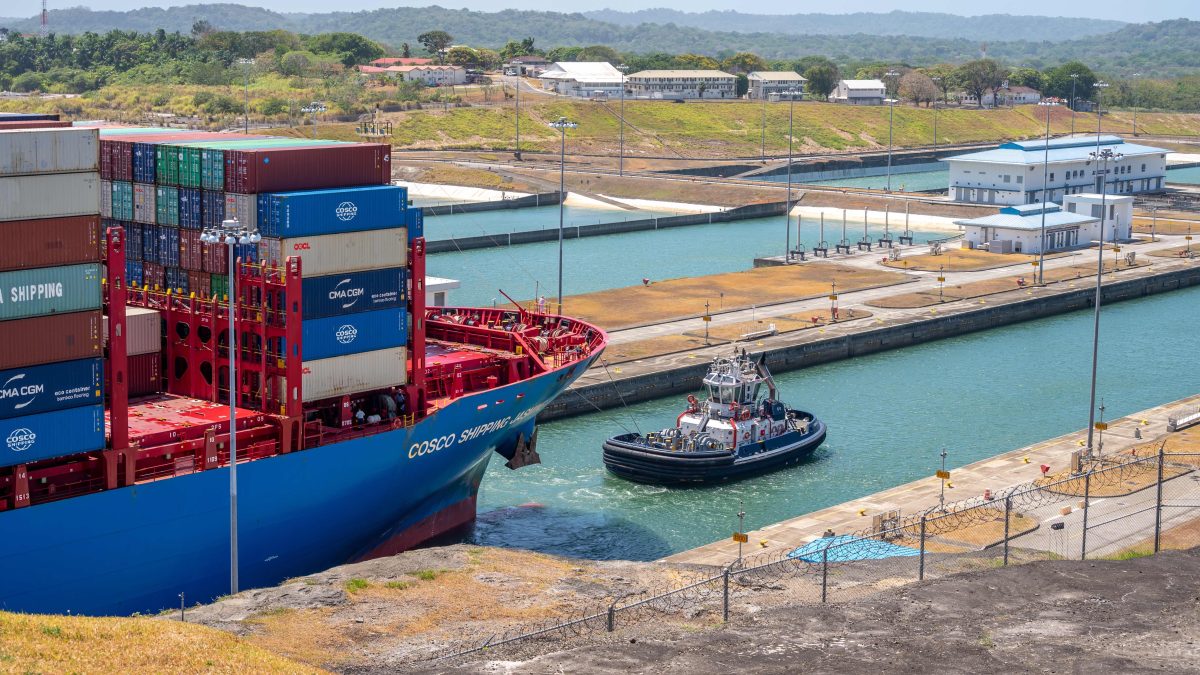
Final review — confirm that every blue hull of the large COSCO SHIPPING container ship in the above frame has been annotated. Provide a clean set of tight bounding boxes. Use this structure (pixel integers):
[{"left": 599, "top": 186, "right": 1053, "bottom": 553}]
[{"left": 0, "top": 353, "right": 599, "bottom": 615}]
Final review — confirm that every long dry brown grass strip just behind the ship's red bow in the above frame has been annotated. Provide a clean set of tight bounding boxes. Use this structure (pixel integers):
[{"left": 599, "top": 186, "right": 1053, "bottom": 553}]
[{"left": 563, "top": 263, "right": 906, "bottom": 330}]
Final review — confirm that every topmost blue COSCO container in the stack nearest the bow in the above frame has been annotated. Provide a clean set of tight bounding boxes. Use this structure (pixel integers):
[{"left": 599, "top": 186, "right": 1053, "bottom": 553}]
[{"left": 258, "top": 185, "right": 408, "bottom": 237}]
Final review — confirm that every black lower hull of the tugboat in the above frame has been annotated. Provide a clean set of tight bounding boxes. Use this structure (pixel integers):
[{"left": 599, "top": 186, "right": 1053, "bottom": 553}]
[{"left": 604, "top": 419, "right": 826, "bottom": 485}]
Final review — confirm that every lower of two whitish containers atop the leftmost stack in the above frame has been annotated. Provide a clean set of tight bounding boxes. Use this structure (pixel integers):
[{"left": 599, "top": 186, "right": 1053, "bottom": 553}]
[{"left": 0, "top": 170, "right": 100, "bottom": 221}]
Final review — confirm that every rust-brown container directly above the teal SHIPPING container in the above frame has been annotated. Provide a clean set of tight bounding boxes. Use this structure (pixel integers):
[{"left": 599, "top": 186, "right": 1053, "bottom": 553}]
[{"left": 0, "top": 216, "right": 101, "bottom": 271}]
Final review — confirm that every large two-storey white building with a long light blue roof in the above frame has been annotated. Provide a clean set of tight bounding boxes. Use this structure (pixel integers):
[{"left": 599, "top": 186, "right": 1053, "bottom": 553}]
[{"left": 942, "top": 136, "right": 1166, "bottom": 204}]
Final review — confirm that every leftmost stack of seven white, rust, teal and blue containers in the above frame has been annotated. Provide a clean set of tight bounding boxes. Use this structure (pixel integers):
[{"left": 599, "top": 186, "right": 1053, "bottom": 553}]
[{"left": 0, "top": 128, "right": 104, "bottom": 466}]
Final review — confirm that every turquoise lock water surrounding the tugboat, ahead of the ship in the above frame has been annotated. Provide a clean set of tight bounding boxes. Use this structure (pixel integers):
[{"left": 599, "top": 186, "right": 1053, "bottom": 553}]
[{"left": 472, "top": 283, "right": 1200, "bottom": 560}]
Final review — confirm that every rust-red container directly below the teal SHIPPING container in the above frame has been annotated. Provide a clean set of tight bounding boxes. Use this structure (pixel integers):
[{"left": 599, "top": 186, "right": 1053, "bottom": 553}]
[{"left": 0, "top": 310, "right": 103, "bottom": 370}]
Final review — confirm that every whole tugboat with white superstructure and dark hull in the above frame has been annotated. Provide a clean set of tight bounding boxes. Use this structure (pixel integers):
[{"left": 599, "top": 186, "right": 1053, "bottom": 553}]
[{"left": 604, "top": 351, "right": 826, "bottom": 484}]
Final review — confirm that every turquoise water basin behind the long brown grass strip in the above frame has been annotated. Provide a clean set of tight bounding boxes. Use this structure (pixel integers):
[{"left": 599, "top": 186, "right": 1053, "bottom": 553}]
[{"left": 425, "top": 209, "right": 946, "bottom": 306}]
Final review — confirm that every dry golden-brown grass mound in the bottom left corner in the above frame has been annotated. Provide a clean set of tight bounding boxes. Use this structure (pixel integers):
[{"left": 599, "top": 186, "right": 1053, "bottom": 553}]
[{"left": 0, "top": 613, "right": 323, "bottom": 674}]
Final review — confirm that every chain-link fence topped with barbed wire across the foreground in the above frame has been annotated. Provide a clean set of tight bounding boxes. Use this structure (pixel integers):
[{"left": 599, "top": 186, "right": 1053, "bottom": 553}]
[{"left": 422, "top": 442, "right": 1200, "bottom": 661}]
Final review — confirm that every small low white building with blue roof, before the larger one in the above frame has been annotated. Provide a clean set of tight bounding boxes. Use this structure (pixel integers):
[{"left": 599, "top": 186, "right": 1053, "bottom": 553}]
[{"left": 954, "top": 203, "right": 1100, "bottom": 253}]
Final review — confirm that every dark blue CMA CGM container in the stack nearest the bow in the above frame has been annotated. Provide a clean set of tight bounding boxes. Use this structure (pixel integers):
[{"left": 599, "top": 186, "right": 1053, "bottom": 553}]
[{"left": 301, "top": 267, "right": 404, "bottom": 319}]
